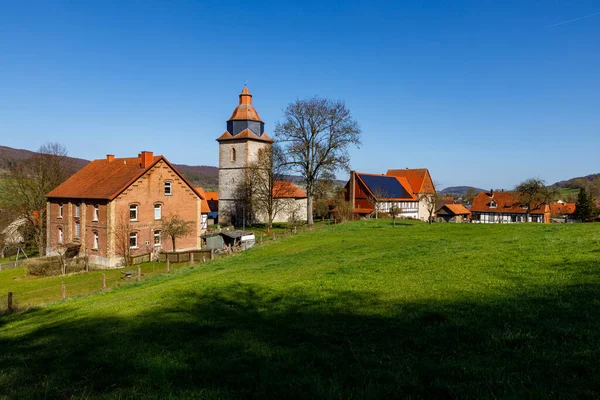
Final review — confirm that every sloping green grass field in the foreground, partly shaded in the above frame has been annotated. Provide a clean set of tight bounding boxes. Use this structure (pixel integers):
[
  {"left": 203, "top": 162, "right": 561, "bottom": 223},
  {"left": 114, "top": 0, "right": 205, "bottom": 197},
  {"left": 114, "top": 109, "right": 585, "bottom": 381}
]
[{"left": 0, "top": 220, "right": 600, "bottom": 399}]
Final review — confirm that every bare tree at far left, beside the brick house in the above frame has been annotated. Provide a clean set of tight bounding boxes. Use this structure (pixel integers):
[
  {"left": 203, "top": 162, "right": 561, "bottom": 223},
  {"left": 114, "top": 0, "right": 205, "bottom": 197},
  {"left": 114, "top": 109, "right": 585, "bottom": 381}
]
[{"left": 0, "top": 143, "right": 75, "bottom": 255}]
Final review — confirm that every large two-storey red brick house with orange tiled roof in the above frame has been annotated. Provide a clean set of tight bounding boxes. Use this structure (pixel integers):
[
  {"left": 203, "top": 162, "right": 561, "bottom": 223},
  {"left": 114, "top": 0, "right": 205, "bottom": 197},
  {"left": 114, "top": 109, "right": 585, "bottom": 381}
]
[{"left": 46, "top": 151, "right": 205, "bottom": 267}]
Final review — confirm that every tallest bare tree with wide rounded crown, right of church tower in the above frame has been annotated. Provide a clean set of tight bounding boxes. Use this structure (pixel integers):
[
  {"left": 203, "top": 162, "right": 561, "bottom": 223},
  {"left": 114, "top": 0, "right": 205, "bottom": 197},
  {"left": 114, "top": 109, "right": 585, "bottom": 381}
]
[{"left": 275, "top": 97, "right": 361, "bottom": 226}]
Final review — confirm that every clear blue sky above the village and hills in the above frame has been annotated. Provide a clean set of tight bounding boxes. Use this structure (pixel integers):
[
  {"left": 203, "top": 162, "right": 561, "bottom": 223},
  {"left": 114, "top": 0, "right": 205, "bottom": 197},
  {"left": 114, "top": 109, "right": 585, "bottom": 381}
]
[{"left": 0, "top": 0, "right": 600, "bottom": 188}]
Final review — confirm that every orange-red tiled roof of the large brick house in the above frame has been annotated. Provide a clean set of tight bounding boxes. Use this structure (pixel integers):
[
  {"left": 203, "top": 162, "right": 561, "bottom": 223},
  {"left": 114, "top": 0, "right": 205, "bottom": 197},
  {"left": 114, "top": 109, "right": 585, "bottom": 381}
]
[{"left": 46, "top": 153, "right": 202, "bottom": 200}]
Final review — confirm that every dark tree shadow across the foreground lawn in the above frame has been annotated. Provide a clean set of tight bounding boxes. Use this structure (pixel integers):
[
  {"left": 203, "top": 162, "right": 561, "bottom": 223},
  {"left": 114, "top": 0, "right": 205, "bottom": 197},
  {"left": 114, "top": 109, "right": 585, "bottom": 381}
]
[{"left": 0, "top": 276, "right": 600, "bottom": 399}]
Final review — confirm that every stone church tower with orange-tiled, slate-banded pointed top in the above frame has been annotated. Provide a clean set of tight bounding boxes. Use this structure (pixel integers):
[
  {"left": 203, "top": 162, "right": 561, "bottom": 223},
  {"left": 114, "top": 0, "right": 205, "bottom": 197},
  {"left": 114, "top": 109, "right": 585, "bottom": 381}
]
[{"left": 217, "top": 87, "right": 273, "bottom": 226}]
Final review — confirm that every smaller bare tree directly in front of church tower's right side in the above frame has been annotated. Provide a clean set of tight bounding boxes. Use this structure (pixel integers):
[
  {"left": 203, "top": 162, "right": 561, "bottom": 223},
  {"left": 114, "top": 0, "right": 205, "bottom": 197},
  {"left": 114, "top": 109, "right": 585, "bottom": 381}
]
[{"left": 244, "top": 146, "right": 293, "bottom": 232}]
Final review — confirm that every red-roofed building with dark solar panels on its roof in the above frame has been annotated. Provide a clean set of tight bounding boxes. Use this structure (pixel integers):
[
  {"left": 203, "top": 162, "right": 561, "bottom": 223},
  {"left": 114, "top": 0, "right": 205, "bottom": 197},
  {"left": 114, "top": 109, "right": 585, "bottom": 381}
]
[{"left": 345, "top": 168, "right": 435, "bottom": 221}]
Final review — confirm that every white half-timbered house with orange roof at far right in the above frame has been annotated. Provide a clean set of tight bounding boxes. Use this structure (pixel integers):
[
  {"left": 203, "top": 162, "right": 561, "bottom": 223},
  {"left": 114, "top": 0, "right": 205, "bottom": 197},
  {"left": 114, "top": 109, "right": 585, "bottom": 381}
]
[{"left": 471, "top": 190, "right": 550, "bottom": 224}]
